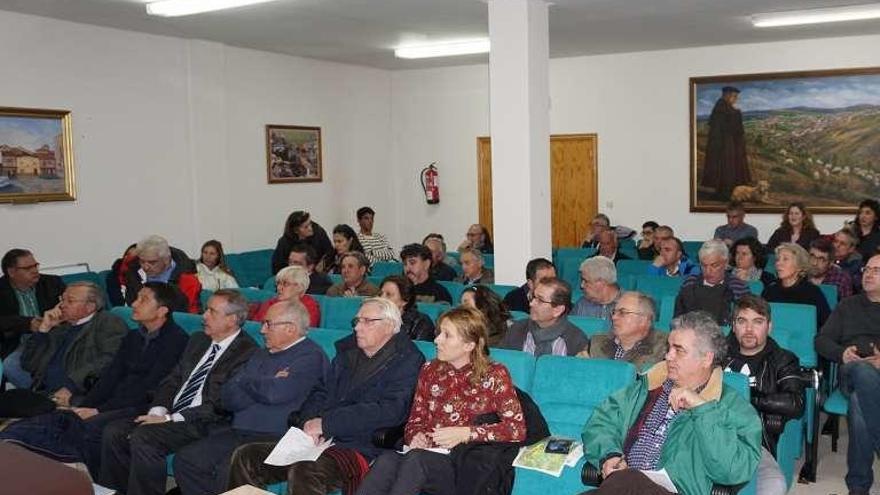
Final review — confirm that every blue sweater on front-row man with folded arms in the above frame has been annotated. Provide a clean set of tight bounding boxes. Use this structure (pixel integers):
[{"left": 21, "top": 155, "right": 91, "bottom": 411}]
[{"left": 220, "top": 339, "right": 329, "bottom": 435}]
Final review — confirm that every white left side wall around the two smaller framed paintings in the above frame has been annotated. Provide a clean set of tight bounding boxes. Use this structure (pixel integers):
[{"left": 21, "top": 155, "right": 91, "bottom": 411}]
[{"left": 0, "top": 12, "right": 397, "bottom": 269}]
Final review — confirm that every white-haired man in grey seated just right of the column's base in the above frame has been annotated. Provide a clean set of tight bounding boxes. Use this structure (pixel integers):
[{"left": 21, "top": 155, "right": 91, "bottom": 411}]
[{"left": 571, "top": 256, "right": 620, "bottom": 320}]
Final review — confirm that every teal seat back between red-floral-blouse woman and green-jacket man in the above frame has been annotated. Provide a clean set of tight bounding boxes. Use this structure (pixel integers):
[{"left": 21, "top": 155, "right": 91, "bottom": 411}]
[{"left": 531, "top": 356, "right": 636, "bottom": 438}]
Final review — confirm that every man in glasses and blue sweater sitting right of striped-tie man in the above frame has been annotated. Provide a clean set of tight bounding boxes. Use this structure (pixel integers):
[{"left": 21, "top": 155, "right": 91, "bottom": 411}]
[{"left": 174, "top": 301, "right": 329, "bottom": 495}]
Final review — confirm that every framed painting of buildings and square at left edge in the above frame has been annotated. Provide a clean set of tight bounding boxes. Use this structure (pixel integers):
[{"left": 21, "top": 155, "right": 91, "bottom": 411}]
[{"left": 0, "top": 107, "right": 76, "bottom": 203}]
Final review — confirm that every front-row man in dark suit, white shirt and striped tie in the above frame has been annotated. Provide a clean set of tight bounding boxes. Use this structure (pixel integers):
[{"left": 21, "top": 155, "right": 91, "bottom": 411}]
[{"left": 100, "top": 290, "right": 257, "bottom": 495}]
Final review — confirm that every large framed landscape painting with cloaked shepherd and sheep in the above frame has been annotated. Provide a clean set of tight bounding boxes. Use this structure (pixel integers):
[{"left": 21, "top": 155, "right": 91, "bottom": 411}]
[{"left": 690, "top": 67, "right": 880, "bottom": 213}]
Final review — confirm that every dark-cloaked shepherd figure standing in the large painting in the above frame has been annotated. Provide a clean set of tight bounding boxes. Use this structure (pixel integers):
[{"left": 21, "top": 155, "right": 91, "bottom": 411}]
[{"left": 700, "top": 86, "right": 752, "bottom": 201}]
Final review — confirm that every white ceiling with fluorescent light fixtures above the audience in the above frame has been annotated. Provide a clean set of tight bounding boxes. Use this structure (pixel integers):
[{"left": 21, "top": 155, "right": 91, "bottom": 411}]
[{"left": 0, "top": 0, "right": 880, "bottom": 69}]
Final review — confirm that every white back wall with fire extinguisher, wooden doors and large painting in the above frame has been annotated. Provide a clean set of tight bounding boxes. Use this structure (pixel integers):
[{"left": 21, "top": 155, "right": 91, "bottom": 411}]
[{"left": 392, "top": 36, "right": 880, "bottom": 247}]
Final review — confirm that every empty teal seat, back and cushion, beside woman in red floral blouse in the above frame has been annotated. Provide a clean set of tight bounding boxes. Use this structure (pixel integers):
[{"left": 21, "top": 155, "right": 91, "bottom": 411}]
[{"left": 514, "top": 356, "right": 636, "bottom": 495}]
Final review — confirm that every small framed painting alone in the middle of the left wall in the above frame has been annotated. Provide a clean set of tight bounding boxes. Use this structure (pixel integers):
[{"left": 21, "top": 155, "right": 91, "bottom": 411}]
[{"left": 266, "top": 125, "right": 323, "bottom": 184}]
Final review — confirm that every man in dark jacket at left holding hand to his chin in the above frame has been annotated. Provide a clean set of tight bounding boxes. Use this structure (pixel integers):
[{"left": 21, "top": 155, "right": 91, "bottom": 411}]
[{"left": 0, "top": 282, "right": 128, "bottom": 418}]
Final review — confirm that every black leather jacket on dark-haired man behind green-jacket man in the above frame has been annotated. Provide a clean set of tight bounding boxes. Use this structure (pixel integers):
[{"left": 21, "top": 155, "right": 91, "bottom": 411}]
[{"left": 725, "top": 332, "right": 804, "bottom": 457}]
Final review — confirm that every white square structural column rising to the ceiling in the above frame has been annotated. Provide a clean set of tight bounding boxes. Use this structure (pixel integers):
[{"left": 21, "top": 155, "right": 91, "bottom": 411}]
[{"left": 489, "top": 0, "right": 551, "bottom": 285}]
